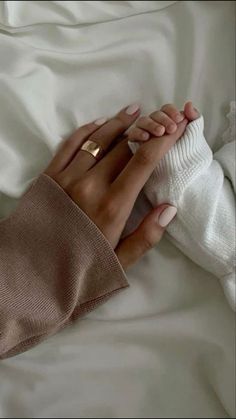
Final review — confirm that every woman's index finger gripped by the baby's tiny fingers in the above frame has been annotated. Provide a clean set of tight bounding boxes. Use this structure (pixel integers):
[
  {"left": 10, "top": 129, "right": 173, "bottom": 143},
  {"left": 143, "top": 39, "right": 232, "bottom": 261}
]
[{"left": 112, "top": 119, "right": 188, "bottom": 201}]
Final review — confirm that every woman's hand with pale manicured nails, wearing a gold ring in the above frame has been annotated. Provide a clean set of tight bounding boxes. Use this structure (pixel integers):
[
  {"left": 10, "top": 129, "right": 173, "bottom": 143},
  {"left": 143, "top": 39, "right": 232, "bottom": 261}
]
[{"left": 45, "top": 105, "right": 184, "bottom": 268}]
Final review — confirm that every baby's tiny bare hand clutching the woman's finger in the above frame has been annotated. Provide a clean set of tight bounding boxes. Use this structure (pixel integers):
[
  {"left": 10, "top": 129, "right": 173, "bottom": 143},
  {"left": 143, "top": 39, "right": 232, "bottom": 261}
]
[{"left": 129, "top": 102, "right": 200, "bottom": 141}]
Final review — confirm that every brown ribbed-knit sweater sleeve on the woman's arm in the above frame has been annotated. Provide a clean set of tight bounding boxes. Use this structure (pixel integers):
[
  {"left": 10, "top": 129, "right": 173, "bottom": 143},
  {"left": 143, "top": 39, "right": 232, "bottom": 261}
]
[{"left": 0, "top": 174, "right": 128, "bottom": 359}]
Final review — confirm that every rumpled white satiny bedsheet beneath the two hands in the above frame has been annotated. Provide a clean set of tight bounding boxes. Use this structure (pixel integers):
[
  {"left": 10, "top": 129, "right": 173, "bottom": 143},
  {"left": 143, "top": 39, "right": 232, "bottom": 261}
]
[{"left": 0, "top": 1, "right": 235, "bottom": 418}]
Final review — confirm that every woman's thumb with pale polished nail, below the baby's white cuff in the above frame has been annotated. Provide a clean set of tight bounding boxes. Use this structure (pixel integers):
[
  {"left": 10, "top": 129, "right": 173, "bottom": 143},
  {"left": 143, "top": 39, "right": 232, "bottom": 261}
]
[{"left": 115, "top": 204, "right": 177, "bottom": 269}]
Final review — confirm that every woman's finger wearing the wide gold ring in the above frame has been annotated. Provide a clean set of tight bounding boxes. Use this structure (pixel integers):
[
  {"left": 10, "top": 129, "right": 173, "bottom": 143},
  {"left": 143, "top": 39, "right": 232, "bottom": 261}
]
[{"left": 64, "top": 104, "right": 140, "bottom": 176}]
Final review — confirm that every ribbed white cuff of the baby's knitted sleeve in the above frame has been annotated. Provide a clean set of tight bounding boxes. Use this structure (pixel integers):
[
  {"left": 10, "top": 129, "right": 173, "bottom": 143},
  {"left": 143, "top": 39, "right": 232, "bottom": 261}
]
[{"left": 129, "top": 116, "right": 213, "bottom": 204}]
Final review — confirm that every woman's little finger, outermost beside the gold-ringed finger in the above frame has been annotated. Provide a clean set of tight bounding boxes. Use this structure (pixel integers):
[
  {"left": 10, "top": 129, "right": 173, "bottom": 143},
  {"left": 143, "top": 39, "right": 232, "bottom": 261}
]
[{"left": 45, "top": 118, "right": 106, "bottom": 176}]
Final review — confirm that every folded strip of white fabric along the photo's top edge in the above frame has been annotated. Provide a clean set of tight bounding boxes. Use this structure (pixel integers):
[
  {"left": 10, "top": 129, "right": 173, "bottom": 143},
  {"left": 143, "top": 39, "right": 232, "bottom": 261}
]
[{"left": 0, "top": 1, "right": 177, "bottom": 26}]
